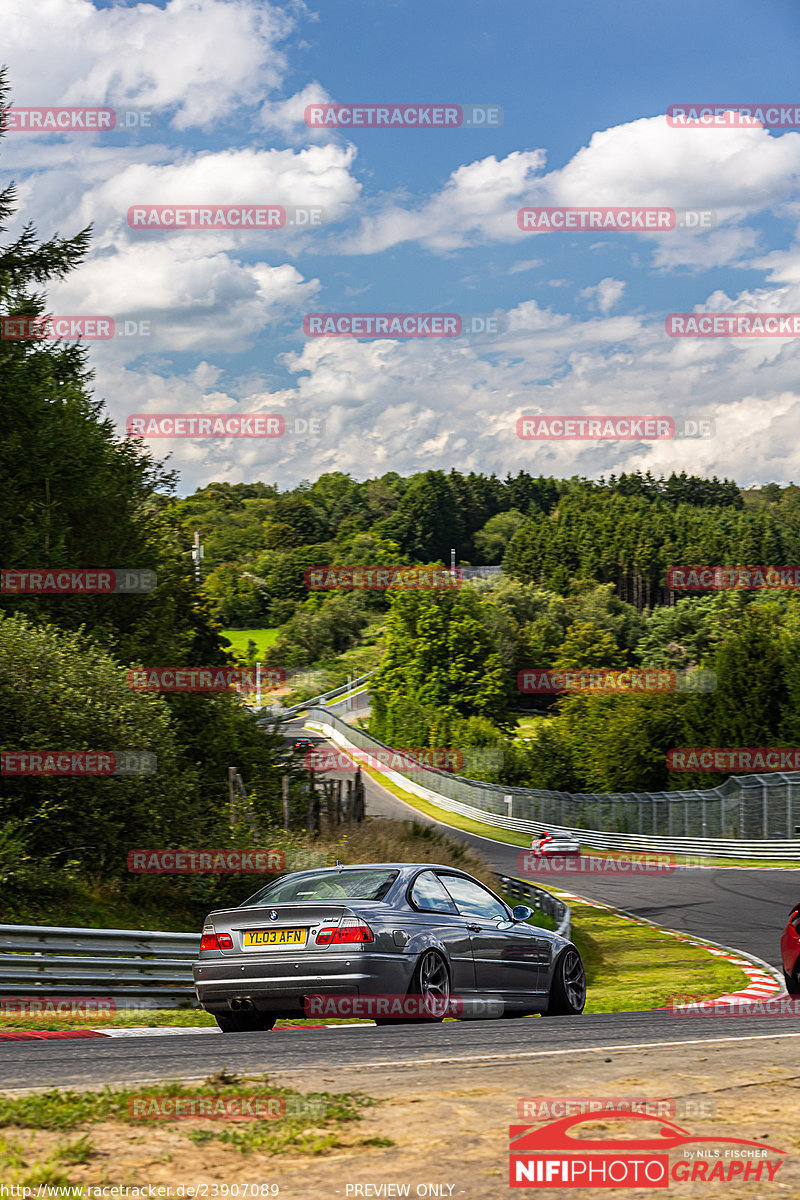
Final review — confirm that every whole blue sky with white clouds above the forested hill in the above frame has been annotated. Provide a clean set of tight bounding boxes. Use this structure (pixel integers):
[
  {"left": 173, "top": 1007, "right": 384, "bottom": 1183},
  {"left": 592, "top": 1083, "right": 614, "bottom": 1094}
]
[{"left": 0, "top": 0, "right": 800, "bottom": 492}]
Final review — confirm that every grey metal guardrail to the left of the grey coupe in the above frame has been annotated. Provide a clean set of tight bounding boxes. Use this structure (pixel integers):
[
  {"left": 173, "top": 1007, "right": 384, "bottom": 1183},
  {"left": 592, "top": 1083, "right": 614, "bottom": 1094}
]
[{"left": 0, "top": 925, "right": 200, "bottom": 1008}]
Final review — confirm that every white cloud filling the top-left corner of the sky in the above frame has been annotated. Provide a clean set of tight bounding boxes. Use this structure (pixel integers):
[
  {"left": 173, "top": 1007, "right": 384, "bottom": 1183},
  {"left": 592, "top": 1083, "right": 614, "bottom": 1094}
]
[{"left": 2, "top": 0, "right": 298, "bottom": 128}]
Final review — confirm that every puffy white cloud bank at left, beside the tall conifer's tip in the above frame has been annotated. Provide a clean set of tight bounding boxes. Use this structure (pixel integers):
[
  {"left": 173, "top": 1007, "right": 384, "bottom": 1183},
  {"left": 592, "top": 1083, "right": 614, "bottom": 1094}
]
[{"left": 10, "top": 144, "right": 360, "bottom": 358}]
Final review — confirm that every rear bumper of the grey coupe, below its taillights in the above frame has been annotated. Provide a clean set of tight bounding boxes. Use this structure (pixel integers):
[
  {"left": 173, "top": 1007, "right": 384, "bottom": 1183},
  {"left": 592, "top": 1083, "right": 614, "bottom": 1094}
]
[{"left": 192, "top": 954, "right": 414, "bottom": 1013}]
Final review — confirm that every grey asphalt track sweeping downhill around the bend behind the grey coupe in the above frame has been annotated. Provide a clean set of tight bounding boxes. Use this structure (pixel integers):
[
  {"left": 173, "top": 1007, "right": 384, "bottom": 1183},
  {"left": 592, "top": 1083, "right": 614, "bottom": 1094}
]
[{"left": 287, "top": 721, "right": 800, "bottom": 968}]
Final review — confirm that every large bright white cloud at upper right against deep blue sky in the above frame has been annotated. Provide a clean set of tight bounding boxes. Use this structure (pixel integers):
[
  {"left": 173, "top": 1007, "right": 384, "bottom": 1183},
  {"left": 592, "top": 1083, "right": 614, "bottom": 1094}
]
[{"left": 338, "top": 116, "right": 800, "bottom": 269}]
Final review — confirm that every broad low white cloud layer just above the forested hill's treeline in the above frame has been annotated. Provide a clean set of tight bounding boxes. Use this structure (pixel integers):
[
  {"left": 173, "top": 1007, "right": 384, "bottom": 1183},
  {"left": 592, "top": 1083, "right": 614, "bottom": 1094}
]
[{"left": 98, "top": 276, "right": 800, "bottom": 490}]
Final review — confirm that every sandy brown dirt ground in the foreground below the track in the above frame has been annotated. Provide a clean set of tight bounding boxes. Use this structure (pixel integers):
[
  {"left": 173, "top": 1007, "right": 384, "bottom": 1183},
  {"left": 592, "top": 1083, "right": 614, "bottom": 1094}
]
[{"left": 5, "top": 1037, "right": 800, "bottom": 1200}]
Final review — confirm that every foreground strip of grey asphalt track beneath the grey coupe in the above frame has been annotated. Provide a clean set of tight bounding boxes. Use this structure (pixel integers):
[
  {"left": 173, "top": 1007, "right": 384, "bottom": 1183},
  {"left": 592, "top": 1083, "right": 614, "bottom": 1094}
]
[{"left": 0, "top": 1010, "right": 800, "bottom": 1091}]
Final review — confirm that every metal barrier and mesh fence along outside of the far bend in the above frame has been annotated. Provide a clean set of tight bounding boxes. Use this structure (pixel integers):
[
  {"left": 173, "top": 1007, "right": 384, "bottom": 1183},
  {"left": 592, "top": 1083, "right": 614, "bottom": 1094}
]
[{"left": 306, "top": 708, "right": 800, "bottom": 859}]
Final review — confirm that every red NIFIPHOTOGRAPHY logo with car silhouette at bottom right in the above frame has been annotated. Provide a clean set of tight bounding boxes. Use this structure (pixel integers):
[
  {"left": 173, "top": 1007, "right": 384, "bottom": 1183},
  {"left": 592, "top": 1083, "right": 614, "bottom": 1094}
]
[{"left": 509, "top": 1109, "right": 786, "bottom": 1188}]
